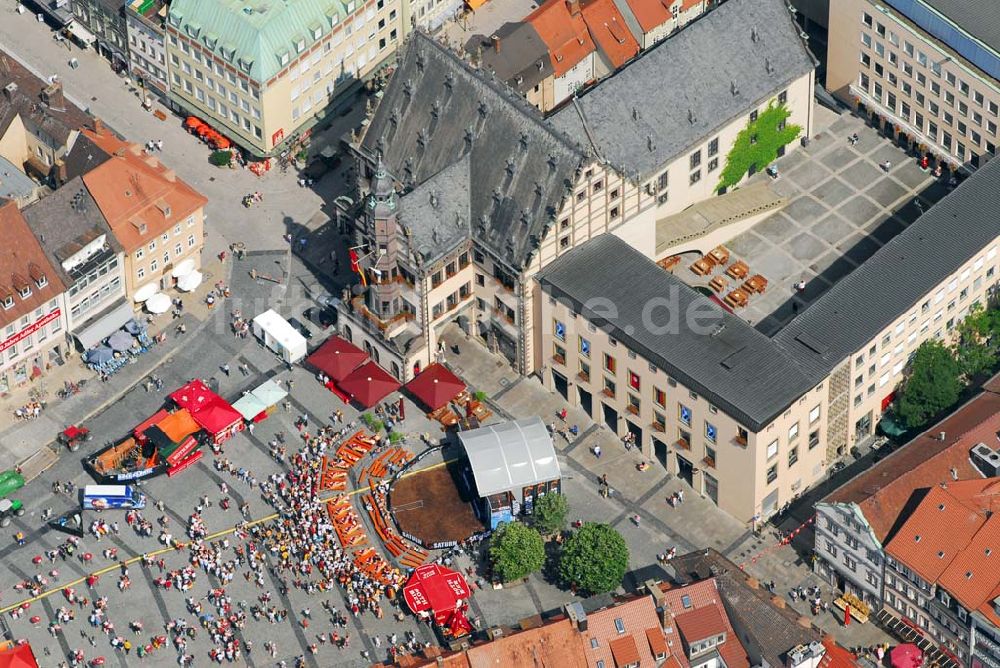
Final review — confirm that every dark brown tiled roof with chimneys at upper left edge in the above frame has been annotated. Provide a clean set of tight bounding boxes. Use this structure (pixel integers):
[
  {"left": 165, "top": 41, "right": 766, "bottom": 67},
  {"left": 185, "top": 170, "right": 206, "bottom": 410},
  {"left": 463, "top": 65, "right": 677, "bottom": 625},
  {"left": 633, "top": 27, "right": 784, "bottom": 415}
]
[{"left": 0, "top": 51, "right": 90, "bottom": 150}]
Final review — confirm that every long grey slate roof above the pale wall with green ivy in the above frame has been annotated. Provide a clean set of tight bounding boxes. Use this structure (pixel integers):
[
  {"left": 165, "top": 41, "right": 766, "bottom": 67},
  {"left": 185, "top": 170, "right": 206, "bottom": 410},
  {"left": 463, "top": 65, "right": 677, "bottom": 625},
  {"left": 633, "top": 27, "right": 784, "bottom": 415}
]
[{"left": 550, "top": 0, "right": 815, "bottom": 178}]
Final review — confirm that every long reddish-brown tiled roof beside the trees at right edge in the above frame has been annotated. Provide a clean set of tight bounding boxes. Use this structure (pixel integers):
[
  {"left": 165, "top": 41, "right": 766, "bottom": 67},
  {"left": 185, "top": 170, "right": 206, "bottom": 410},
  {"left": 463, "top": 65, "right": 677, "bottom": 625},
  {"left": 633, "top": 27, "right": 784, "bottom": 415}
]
[{"left": 824, "top": 392, "right": 1000, "bottom": 543}]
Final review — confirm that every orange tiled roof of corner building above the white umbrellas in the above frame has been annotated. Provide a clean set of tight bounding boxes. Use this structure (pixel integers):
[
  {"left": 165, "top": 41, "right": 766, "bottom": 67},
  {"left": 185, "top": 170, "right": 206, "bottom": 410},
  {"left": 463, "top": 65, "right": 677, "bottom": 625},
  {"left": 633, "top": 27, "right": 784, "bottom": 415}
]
[{"left": 83, "top": 125, "right": 208, "bottom": 252}]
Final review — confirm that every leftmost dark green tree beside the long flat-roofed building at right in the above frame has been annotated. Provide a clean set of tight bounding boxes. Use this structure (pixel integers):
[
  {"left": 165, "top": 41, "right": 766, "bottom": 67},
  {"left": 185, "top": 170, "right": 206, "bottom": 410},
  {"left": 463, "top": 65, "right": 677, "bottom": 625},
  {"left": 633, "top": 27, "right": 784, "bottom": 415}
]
[{"left": 899, "top": 340, "right": 962, "bottom": 429}]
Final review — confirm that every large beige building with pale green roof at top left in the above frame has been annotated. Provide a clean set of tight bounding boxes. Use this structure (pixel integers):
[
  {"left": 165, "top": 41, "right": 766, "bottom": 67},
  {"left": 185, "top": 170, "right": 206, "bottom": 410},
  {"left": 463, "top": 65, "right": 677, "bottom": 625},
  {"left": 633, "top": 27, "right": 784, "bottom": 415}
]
[{"left": 166, "top": 0, "right": 409, "bottom": 156}]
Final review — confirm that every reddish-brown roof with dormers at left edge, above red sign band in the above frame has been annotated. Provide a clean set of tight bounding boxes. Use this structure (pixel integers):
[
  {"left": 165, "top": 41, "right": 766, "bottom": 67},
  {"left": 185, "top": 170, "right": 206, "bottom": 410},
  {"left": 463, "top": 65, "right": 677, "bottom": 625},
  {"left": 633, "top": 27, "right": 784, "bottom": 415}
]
[{"left": 0, "top": 198, "right": 66, "bottom": 325}]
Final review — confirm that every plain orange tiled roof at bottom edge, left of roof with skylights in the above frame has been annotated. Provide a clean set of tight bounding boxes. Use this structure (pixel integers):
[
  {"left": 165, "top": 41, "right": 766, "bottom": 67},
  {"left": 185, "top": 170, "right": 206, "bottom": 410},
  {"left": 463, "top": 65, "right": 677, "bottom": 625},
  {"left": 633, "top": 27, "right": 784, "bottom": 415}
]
[{"left": 465, "top": 619, "right": 587, "bottom": 668}]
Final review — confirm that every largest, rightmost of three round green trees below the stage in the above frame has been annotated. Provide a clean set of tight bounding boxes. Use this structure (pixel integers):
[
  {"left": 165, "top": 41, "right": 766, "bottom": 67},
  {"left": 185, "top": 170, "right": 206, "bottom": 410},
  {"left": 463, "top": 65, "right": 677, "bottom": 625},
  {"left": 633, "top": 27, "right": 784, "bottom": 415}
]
[{"left": 559, "top": 522, "right": 628, "bottom": 594}]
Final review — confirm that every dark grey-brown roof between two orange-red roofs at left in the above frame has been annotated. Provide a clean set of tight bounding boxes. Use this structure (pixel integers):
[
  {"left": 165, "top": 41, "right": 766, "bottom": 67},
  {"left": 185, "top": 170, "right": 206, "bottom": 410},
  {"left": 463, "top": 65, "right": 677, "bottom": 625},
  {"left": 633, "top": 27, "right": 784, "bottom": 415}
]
[{"left": 21, "top": 177, "right": 122, "bottom": 285}]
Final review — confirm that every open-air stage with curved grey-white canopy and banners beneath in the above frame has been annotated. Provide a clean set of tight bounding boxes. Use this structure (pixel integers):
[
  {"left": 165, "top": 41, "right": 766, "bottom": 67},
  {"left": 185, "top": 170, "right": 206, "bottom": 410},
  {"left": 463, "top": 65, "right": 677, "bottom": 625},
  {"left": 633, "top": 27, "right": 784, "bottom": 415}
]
[{"left": 458, "top": 416, "right": 562, "bottom": 529}]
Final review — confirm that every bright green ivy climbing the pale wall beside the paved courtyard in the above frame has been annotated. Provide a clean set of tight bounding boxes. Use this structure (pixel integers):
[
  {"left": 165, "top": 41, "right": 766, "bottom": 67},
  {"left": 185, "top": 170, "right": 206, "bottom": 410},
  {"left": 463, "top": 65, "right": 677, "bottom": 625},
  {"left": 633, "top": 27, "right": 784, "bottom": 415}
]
[{"left": 715, "top": 102, "right": 802, "bottom": 191}]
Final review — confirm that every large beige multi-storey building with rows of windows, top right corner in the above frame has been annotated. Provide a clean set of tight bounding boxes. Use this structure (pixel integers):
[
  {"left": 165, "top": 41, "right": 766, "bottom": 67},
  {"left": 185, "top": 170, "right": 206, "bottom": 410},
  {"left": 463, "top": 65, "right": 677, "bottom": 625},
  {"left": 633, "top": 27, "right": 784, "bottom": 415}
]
[{"left": 827, "top": 0, "right": 1000, "bottom": 169}]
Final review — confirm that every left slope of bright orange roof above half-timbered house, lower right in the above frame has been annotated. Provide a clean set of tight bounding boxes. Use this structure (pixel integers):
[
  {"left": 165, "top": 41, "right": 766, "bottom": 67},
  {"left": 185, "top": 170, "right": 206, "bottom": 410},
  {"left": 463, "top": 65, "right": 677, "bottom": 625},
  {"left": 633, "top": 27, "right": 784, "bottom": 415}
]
[{"left": 886, "top": 487, "right": 986, "bottom": 583}]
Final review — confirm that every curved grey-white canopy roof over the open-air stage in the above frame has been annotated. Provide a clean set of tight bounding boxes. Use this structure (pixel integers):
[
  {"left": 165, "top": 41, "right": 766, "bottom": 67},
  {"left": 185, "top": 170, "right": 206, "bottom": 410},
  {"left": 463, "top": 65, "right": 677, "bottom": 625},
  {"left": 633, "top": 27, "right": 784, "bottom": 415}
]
[{"left": 458, "top": 416, "right": 561, "bottom": 498}]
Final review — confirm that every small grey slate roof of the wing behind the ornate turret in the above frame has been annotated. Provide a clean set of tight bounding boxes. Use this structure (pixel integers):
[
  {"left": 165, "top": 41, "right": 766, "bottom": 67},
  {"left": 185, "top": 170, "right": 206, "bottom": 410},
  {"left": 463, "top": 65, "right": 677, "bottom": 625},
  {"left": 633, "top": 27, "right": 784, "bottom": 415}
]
[{"left": 399, "top": 155, "right": 471, "bottom": 265}]
